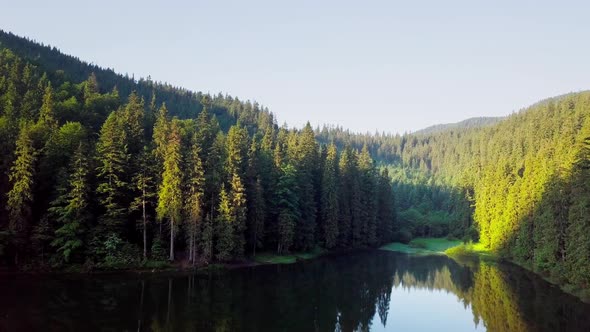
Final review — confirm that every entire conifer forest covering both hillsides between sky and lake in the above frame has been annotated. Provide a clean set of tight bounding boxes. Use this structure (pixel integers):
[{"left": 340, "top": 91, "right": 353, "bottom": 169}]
[{"left": 0, "top": 28, "right": 590, "bottom": 296}]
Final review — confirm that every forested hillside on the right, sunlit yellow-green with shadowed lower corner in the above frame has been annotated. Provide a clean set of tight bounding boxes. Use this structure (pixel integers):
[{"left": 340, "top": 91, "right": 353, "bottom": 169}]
[{"left": 319, "top": 92, "right": 590, "bottom": 288}]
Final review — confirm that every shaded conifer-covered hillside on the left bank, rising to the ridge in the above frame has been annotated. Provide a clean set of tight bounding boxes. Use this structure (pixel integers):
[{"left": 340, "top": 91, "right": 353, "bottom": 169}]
[{"left": 0, "top": 34, "right": 396, "bottom": 268}]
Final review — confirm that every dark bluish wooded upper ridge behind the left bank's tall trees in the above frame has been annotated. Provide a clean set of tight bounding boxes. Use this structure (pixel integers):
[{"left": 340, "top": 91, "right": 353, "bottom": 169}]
[{"left": 0, "top": 29, "right": 269, "bottom": 130}]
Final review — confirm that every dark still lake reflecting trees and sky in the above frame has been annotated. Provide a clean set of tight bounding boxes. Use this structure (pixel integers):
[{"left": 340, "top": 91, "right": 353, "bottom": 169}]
[{"left": 0, "top": 251, "right": 590, "bottom": 332}]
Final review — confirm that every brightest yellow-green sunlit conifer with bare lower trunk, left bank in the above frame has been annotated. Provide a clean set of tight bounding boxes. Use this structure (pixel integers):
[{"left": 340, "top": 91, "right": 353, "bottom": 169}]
[{"left": 157, "top": 119, "right": 182, "bottom": 261}]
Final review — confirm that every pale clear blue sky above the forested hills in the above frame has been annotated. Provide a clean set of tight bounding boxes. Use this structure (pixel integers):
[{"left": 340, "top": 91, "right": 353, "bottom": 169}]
[{"left": 0, "top": 0, "right": 590, "bottom": 132}]
